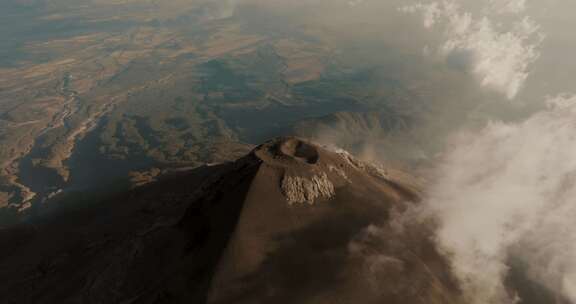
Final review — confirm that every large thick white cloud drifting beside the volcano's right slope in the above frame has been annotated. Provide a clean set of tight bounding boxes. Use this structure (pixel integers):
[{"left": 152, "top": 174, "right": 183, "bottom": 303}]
[{"left": 427, "top": 96, "right": 576, "bottom": 304}]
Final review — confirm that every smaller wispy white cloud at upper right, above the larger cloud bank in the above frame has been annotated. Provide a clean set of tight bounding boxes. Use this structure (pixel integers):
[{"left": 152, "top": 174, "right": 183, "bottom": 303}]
[{"left": 402, "top": 0, "right": 543, "bottom": 99}]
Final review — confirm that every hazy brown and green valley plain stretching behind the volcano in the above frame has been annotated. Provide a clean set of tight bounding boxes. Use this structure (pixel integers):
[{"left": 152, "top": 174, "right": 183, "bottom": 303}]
[{"left": 0, "top": 0, "right": 432, "bottom": 220}]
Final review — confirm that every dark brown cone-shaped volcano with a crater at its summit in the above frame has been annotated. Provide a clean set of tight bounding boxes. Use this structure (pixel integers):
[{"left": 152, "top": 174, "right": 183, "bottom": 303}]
[{"left": 0, "top": 137, "right": 461, "bottom": 304}]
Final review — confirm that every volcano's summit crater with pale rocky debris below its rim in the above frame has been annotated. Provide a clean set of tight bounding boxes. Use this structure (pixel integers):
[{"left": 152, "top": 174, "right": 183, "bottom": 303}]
[{"left": 253, "top": 137, "right": 421, "bottom": 205}]
